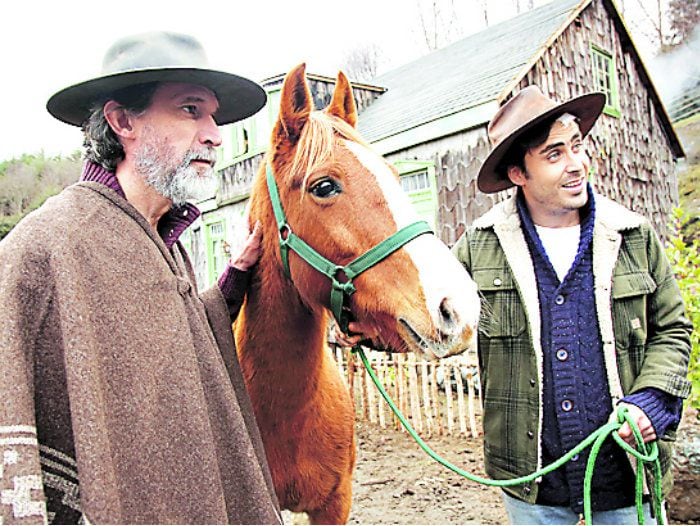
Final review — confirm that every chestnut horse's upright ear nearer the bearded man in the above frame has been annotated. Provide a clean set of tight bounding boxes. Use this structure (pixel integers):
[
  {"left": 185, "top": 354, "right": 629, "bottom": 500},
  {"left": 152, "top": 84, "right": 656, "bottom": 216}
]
[{"left": 276, "top": 64, "right": 313, "bottom": 142}]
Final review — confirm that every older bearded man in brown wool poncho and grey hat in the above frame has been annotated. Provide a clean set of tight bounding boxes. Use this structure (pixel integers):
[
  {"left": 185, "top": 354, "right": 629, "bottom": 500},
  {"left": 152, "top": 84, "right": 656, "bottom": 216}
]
[{"left": 0, "top": 33, "right": 281, "bottom": 524}]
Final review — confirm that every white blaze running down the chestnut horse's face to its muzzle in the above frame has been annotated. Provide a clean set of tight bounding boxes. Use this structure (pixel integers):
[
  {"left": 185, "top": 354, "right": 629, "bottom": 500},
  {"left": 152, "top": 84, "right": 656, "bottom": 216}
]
[{"left": 345, "top": 141, "right": 480, "bottom": 357}]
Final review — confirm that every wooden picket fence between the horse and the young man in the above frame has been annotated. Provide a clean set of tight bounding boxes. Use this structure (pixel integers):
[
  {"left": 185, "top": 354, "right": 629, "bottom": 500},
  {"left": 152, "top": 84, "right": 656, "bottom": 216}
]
[{"left": 331, "top": 347, "right": 481, "bottom": 438}]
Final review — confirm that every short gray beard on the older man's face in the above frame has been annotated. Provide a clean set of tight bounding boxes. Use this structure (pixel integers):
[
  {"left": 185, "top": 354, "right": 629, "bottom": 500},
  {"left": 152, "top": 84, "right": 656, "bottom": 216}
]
[{"left": 135, "top": 139, "right": 218, "bottom": 207}]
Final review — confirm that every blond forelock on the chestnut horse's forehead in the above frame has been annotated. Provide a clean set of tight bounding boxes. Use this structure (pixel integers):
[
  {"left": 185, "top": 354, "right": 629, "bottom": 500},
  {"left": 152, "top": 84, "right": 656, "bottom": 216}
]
[{"left": 291, "top": 111, "right": 369, "bottom": 197}]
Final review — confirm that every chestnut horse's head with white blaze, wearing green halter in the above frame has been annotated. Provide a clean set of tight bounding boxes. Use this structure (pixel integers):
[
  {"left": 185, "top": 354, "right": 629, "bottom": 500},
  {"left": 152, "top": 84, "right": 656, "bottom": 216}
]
[{"left": 251, "top": 60, "right": 480, "bottom": 358}]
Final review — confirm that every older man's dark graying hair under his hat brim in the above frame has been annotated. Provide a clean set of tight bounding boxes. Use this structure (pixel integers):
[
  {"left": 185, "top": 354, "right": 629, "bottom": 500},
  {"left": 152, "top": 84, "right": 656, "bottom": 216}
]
[{"left": 82, "top": 82, "right": 160, "bottom": 171}]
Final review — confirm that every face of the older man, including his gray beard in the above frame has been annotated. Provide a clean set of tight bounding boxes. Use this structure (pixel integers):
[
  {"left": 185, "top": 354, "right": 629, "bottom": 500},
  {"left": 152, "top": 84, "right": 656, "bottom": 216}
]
[{"left": 134, "top": 83, "right": 221, "bottom": 206}]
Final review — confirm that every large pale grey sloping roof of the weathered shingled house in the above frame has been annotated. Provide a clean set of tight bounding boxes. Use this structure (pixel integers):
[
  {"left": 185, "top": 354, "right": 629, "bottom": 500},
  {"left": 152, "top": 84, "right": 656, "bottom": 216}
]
[{"left": 358, "top": 0, "right": 581, "bottom": 146}]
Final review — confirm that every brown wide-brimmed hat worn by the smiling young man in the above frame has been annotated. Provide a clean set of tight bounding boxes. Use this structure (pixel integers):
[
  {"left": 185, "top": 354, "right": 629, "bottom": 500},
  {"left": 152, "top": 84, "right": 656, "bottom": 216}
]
[{"left": 477, "top": 86, "right": 605, "bottom": 194}]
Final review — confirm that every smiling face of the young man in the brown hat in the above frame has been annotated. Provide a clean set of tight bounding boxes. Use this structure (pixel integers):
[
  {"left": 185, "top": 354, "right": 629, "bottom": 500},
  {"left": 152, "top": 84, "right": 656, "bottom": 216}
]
[{"left": 508, "top": 115, "right": 590, "bottom": 227}]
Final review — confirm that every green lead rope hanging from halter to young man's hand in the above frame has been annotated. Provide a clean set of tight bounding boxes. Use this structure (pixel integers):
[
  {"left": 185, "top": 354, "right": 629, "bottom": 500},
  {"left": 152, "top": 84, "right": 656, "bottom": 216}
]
[{"left": 352, "top": 346, "right": 664, "bottom": 524}]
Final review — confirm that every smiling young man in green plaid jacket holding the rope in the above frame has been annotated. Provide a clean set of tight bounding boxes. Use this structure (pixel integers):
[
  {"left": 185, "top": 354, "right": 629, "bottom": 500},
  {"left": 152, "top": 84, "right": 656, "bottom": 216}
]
[{"left": 454, "top": 86, "right": 691, "bottom": 524}]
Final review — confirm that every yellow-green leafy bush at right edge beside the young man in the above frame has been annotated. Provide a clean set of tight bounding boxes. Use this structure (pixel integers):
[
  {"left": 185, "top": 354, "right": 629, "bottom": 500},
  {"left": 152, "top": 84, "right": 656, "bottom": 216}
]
[{"left": 666, "top": 209, "right": 700, "bottom": 409}]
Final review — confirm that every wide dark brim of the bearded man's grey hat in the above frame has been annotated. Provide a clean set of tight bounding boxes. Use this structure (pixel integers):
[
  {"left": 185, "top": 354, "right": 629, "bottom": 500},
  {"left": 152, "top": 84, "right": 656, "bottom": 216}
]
[{"left": 46, "top": 67, "right": 267, "bottom": 126}]
